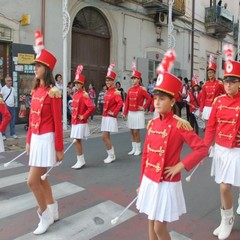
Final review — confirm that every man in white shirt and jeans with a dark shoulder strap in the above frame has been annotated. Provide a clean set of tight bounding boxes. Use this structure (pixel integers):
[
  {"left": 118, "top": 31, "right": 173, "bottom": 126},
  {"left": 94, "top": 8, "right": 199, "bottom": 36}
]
[{"left": 1, "top": 76, "right": 18, "bottom": 140}]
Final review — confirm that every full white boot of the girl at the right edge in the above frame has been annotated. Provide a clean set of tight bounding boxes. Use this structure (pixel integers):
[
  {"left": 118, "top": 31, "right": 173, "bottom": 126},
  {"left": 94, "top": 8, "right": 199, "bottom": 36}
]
[{"left": 213, "top": 208, "right": 234, "bottom": 240}]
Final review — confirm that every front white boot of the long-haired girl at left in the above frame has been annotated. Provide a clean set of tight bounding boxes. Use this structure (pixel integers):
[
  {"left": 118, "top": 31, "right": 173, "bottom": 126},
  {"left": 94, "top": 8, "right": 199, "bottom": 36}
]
[{"left": 33, "top": 208, "right": 54, "bottom": 235}]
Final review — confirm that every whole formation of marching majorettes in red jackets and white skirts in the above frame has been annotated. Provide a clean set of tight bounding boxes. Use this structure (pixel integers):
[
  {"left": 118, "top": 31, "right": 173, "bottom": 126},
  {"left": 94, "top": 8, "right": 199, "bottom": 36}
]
[{"left": 0, "top": 31, "right": 240, "bottom": 240}]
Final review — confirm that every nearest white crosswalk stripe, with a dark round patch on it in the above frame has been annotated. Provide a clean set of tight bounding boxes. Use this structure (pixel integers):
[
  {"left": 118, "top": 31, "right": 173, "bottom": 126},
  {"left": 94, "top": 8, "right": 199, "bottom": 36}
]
[{"left": 16, "top": 201, "right": 136, "bottom": 240}]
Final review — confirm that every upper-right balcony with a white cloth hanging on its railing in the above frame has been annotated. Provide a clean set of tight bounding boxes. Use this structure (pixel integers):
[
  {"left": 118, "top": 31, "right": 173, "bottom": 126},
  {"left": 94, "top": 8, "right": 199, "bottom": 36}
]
[{"left": 205, "top": 6, "right": 234, "bottom": 38}]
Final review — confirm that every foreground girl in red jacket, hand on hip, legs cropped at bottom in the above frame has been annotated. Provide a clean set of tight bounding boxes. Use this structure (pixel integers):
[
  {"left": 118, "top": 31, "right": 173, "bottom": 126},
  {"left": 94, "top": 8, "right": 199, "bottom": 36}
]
[{"left": 137, "top": 50, "right": 208, "bottom": 240}]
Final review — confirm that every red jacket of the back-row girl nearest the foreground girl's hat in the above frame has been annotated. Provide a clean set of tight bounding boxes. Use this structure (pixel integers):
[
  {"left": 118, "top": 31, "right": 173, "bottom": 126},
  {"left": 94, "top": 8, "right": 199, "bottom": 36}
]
[{"left": 123, "top": 85, "right": 152, "bottom": 115}]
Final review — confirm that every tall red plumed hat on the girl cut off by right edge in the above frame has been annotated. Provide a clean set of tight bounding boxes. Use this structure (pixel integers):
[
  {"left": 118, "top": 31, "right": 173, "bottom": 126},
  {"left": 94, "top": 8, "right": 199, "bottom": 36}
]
[{"left": 223, "top": 44, "right": 240, "bottom": 80}]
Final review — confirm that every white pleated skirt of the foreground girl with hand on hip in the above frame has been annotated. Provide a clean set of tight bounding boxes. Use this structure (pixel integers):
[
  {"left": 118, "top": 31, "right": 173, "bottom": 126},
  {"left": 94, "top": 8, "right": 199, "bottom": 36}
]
[{"left": 136, "top": 175, "right": 186, "bottom": 222}]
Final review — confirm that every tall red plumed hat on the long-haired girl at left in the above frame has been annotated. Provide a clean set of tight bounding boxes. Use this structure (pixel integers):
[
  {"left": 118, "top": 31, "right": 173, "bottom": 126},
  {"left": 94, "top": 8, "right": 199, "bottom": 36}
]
[{"left": 34, "top": 30, "right": 57, "bottom": 71}]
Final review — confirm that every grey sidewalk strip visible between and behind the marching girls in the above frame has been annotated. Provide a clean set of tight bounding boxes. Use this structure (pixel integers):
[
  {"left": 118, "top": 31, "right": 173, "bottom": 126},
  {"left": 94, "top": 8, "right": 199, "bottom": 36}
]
[{"left": 4, "top": 114, "right": 152, "bottom": 151}]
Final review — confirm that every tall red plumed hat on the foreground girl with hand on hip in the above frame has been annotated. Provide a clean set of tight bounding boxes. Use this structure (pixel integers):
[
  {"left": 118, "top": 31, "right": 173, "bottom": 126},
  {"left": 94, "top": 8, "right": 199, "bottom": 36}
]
[{"left": 154, "top": 50, "right": 182, "bottom": 98}]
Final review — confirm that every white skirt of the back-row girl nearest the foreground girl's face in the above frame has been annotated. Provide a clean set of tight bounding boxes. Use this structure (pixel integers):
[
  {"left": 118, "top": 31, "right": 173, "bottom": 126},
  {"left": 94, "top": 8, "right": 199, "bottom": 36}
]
[{"left": 127, "top": 111, "right": 146, "bottom": 129}]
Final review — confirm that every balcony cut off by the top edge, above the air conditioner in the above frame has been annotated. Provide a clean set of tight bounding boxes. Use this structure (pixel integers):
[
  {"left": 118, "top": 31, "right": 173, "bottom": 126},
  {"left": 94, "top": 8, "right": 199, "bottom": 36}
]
[{"left": 142, "top": 0, "right": 185, "bottom": 17}]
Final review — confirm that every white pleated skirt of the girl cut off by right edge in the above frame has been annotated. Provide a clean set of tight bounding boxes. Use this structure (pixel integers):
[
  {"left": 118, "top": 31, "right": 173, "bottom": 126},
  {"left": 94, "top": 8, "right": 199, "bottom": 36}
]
[{"left": 211, "top": 144, "right": 240, "bottom": 187}]
